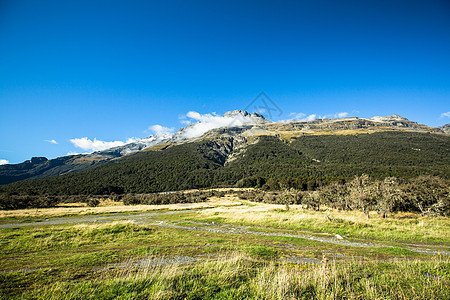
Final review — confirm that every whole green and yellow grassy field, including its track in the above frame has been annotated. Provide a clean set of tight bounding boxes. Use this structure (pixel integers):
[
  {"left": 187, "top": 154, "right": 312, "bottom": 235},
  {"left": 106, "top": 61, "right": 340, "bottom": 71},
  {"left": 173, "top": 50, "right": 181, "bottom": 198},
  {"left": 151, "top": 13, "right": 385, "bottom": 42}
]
[{"left": 0, "top": 198, "right": 450, "bottom": 299}]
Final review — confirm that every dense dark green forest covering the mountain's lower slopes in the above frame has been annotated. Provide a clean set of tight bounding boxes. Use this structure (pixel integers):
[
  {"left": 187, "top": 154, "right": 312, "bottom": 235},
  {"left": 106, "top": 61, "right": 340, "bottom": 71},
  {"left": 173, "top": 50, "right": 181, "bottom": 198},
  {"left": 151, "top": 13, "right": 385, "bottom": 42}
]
[{"left": 0, "top": 132, "right": 450, "bottom": 196}]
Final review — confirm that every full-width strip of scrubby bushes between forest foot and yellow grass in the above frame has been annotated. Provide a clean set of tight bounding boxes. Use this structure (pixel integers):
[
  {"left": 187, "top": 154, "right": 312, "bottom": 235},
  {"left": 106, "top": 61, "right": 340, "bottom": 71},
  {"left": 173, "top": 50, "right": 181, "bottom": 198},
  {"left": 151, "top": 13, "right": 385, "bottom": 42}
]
[{"left": 0, "top": 174, "right": 450, "bottom": 218}]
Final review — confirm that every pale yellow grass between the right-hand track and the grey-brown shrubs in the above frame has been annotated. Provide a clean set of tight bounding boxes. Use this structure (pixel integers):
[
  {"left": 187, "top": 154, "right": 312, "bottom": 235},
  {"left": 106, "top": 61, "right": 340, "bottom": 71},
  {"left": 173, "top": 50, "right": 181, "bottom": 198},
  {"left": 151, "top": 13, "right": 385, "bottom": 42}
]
[{"left": 197, "top": 203, "right": 450, "bottom": 244}]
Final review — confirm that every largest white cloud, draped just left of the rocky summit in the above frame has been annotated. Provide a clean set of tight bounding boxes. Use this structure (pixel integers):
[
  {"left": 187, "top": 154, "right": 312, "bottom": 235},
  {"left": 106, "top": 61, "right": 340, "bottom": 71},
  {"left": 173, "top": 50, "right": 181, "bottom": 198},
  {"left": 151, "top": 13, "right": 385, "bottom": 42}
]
[{"left": 182, "top": 111, "right": 255, "bottom": 138}]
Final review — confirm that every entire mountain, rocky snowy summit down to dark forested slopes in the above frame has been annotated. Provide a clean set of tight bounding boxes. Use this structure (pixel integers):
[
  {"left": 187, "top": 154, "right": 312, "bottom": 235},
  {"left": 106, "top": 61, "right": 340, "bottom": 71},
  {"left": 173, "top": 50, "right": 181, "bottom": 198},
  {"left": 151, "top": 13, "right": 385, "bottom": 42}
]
[{"left": 0, "top": 110, "right": 450, "bottom": 193}]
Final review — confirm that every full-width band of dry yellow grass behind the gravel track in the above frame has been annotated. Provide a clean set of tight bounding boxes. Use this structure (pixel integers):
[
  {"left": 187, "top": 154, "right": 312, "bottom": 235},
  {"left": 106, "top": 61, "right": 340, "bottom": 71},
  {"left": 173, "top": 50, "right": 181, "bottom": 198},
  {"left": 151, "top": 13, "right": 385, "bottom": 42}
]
[{"left": 0, "top": 197, "right": 450, "bottom": 244}]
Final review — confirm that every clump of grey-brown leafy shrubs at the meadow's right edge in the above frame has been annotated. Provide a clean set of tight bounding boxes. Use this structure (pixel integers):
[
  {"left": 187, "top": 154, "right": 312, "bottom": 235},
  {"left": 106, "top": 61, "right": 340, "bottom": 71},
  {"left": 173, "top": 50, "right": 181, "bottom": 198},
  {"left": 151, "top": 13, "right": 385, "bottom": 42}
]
[{"left": 312, "top": 174, "right": 450, "bottom": 218}]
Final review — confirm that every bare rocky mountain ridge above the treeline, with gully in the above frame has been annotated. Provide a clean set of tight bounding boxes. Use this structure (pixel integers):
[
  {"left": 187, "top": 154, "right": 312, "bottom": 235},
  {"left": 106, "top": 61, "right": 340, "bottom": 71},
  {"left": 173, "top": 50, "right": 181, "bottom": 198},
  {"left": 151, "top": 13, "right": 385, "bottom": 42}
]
[{"left": 0, "top": 110, "right": 448, "bottom": 184}]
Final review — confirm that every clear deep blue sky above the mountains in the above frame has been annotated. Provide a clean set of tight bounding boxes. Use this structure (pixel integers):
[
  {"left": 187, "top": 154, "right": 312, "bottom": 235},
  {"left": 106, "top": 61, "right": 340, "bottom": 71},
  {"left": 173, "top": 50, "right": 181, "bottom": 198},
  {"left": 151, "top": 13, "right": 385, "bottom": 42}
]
[{"left": 0, "top": 0, "right": 450, "bottom": 163}]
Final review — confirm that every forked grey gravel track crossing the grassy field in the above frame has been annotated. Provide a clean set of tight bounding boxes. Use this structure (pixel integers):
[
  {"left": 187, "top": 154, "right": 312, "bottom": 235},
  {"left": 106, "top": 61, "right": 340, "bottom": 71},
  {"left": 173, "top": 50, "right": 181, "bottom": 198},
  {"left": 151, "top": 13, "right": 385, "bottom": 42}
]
[{"left": 0, "top": 210, "right": 450, "bottom": 256}]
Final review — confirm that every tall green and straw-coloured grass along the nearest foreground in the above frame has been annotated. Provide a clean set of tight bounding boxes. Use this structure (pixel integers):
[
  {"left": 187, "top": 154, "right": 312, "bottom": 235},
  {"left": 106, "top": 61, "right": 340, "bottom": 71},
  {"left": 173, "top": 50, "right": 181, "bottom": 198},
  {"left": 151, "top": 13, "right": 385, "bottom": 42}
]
[{"left": 2, "top": 253, "right": 450, "bottom": 299}]
